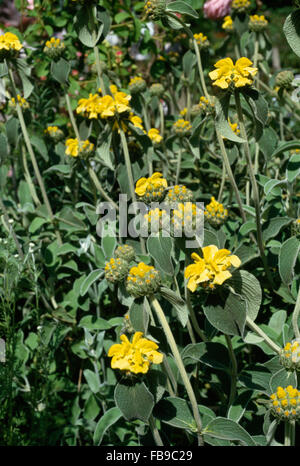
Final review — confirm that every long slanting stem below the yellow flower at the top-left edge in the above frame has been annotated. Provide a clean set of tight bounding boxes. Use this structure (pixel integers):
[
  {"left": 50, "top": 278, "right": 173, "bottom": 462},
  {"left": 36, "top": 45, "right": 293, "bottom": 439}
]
[{"left": 7, "top": 64, "right": 62, "bottom": 245}]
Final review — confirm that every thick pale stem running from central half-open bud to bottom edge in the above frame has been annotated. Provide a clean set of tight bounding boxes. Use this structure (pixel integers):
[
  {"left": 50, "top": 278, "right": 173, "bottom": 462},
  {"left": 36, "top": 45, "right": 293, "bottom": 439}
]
[{"left": 150, "top": 296, "right": 203, "bottom": 446}]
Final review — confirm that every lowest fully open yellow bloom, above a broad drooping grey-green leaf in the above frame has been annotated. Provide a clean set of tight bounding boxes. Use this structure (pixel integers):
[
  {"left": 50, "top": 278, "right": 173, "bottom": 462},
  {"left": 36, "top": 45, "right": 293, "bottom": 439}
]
[{"left": 108, "top": 332, "right": 163, "bottom": 374}]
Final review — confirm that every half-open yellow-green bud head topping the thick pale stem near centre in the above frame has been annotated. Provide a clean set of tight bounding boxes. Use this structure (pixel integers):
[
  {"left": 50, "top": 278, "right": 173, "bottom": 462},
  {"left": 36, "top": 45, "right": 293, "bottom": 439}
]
[{"left": 126, "top": 262, "right": 161, "bottom": 298}]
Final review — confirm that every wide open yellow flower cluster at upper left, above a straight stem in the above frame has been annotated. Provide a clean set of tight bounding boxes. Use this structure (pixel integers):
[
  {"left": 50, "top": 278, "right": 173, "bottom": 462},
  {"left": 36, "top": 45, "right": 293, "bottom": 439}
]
[{"left": 76, "top": 85, "right": 131, "bottom": 119}]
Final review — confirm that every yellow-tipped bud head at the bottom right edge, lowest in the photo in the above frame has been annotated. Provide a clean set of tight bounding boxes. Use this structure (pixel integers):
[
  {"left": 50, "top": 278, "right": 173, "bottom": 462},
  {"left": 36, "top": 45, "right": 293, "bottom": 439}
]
[{"left": 270, "top": 385, "right": 300, "bottom": 420}]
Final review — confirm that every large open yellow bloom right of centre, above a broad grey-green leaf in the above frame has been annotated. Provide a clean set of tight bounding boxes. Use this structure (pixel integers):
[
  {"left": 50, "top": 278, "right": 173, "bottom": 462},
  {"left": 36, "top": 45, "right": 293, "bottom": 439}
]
[{"left": 184, "top": 245, "right": 241, "bottom": 292}]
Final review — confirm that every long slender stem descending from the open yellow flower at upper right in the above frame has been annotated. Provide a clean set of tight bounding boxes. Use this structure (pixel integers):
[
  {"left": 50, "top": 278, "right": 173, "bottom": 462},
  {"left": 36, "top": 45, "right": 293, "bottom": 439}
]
[{"left": 235, "top": 91, "right": 273, "bottom": 288}]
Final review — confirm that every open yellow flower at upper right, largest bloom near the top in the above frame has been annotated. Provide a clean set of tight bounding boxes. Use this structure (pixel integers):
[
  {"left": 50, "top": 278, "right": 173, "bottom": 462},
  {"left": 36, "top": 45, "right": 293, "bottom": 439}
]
[{"left": 209, "top": 57, "right": 258, "bottom": 89}]
